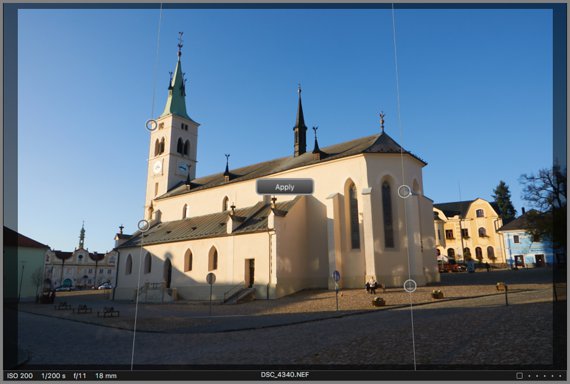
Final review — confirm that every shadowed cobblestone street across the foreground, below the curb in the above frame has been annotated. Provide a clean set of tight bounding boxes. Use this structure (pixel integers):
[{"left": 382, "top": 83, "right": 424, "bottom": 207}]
[{"left": 15, "top": 268, "right": 553, "bottom": 365}]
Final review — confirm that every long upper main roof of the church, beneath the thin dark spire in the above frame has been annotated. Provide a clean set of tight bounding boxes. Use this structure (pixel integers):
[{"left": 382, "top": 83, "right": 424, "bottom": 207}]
[{"left": 157, "top": 132, "right": 427, "bottom": 200}]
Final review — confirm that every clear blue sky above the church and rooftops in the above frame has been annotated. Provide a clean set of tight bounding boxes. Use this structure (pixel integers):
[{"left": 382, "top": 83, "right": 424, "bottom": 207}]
[{"left": 18, "top": 9, "right": 552, "bottom": 252}]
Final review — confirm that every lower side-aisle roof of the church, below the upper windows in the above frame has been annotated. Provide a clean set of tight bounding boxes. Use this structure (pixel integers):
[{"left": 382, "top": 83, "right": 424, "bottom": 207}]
[{"left": 117, "top": 197, "right": 300, "bottom": 248}]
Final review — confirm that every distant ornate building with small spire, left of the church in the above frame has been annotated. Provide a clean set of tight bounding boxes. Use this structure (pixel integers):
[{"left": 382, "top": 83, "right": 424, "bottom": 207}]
[{"left": 45, "top": 227, "right": 117, "bottom": 289}]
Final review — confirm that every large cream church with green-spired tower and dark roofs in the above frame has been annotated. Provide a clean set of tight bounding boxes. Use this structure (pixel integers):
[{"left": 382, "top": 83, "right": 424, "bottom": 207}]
[{"left": 114, "top": 39, "right": 439, "bottom": 302}]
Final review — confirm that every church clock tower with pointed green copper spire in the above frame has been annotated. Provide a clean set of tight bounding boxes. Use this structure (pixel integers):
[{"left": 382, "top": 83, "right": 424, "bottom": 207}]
[{"left": 145, "top": 32, "right": 200, "bottom": 220}]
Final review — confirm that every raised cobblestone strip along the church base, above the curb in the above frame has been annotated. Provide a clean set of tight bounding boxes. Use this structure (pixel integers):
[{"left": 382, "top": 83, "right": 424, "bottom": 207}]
[{"left": 16, "top": 269, "right": 551, "bottom": 333}]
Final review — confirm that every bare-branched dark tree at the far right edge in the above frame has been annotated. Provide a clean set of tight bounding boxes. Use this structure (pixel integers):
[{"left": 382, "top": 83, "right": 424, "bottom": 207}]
[{"left": 520, "top": 165, "right": 567, "bottom": 249}]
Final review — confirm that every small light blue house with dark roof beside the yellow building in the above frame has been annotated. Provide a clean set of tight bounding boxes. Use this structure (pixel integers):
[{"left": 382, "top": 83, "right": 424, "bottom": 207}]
[{"left": 499, "top": 210, "right": 554, "bottom": 268}]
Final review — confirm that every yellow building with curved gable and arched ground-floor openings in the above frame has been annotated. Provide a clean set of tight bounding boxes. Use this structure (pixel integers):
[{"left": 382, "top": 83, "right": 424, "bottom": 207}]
[{"left": 433, "top": 198, "right": 506, "bottom": 264}]
